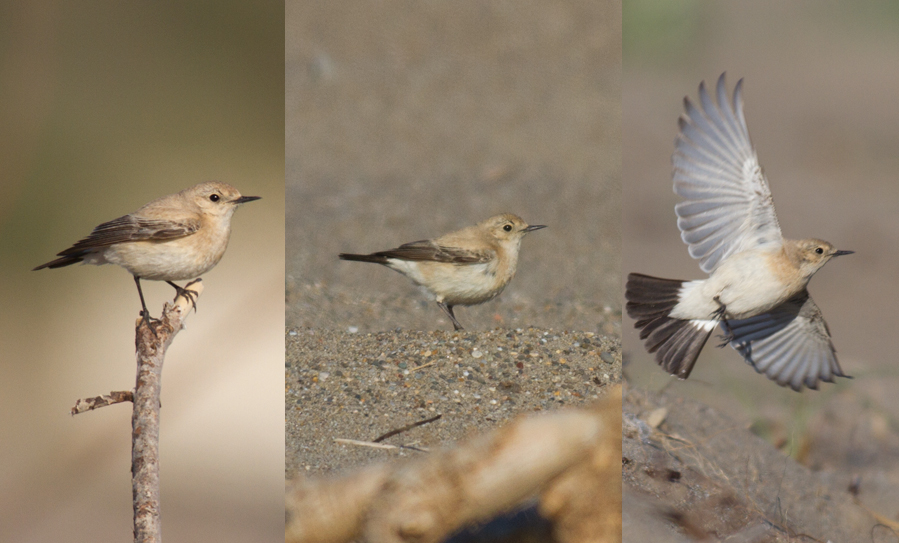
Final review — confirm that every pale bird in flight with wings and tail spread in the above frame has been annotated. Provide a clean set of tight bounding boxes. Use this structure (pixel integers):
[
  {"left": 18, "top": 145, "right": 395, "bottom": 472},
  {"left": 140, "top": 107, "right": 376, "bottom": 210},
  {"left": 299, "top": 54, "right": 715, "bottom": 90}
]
[{"left": 625, "top": 74, "right": 852, "bottom": 391}]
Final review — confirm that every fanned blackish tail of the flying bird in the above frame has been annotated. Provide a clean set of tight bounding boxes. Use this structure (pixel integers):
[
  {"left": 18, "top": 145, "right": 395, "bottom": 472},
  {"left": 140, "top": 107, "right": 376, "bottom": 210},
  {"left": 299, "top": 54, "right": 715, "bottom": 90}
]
[{"left": 624, "top": 273, "right": 715, "bottom": 379}]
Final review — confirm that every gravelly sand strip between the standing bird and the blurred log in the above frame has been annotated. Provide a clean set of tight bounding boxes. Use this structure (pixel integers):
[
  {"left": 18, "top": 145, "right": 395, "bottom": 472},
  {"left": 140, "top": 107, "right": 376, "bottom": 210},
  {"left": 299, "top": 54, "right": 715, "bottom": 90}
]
[{"left": 286, "top": 328, "right": 621, "bottom": 478}]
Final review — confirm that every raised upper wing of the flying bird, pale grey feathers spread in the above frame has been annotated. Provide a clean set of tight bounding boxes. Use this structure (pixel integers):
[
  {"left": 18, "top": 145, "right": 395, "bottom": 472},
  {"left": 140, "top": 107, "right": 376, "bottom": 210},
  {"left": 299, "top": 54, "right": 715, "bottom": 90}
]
[{"left": 672, "top": 74, "right": 783, "bottom": 273}]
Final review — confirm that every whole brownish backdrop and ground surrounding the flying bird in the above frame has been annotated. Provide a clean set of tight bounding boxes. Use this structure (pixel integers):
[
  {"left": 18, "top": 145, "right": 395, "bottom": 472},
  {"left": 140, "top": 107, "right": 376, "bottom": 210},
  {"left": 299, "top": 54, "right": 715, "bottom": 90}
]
[{"left": 622, "top": 2, "right": 899, "bottom": 541}]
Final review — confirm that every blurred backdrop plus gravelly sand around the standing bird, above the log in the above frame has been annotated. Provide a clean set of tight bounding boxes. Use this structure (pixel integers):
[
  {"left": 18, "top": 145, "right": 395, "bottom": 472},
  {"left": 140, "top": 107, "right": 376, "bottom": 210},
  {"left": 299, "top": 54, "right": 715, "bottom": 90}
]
[{"left": 286, "top": 1, "right": 621, "bottom": 492}]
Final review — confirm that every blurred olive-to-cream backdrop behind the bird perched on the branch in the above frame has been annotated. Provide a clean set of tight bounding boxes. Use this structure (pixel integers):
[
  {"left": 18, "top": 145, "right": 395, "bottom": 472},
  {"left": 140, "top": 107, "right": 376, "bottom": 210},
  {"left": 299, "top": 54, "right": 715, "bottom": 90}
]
[{"left": 0, "top": 1, "right": 284, "bottom": 542}]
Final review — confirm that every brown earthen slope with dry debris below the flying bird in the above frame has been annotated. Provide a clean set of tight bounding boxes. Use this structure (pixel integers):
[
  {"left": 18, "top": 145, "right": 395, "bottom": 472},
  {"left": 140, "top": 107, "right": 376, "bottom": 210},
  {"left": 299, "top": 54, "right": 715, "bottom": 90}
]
[{"left": 622, "top": 389, "right": 889, "bottom": 542}]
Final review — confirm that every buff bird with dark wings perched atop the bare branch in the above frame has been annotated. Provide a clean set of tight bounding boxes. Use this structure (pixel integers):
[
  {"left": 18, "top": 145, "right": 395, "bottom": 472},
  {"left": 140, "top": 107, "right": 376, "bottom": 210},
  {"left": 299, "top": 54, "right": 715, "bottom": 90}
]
[{"left": 34, "top": 181, "right": 259, "bottom": 326}]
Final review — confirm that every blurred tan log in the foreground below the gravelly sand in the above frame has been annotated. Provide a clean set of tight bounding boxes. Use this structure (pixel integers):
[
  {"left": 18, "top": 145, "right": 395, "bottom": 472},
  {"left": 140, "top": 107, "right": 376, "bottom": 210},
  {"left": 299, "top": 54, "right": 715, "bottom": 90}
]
[{"left": 285, "top": 388, "right": 621, "bottom": 543}]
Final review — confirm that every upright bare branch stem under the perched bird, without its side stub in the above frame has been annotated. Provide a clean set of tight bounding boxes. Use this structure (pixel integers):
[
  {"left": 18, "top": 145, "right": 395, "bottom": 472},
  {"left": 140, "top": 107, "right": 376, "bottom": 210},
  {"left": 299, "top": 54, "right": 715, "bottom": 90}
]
[{"left": 131, "top": 279, "right": 203, "bottom": 543}]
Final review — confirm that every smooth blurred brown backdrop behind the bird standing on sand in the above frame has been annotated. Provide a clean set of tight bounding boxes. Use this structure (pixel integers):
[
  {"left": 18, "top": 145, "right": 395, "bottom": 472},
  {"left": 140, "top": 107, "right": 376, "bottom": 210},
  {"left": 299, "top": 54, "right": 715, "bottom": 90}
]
[{"left": 286, "top": 0, "right": 621, "bottom": 336}]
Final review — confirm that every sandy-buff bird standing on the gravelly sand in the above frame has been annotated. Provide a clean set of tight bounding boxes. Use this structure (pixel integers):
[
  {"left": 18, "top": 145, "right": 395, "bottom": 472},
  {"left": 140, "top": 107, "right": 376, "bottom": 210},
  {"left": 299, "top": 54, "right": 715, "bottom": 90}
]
[{"left": 340, "top": 213, "right": 546, "bottom": 330}]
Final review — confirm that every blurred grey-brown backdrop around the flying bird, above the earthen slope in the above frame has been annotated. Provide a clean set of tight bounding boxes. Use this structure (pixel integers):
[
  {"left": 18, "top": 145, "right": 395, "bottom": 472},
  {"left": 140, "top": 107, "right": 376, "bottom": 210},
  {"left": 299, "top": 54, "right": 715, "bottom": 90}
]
[{"left": 622, "top": 0, "right": 899, "bottom": 536}]
